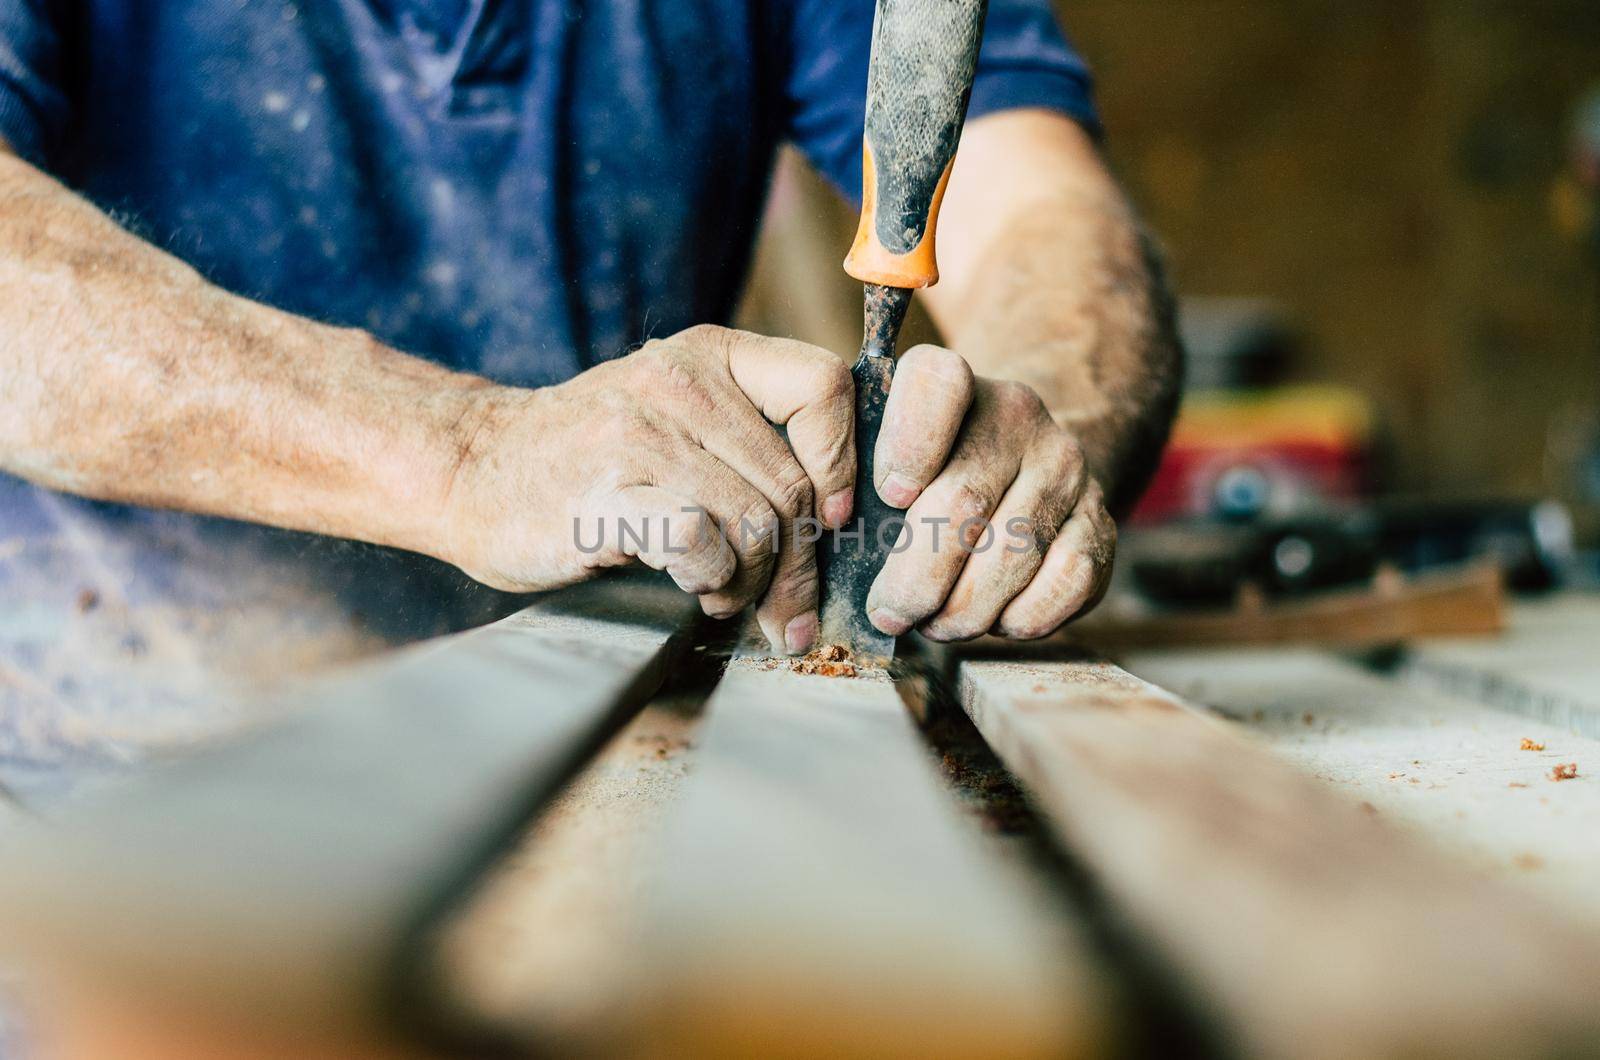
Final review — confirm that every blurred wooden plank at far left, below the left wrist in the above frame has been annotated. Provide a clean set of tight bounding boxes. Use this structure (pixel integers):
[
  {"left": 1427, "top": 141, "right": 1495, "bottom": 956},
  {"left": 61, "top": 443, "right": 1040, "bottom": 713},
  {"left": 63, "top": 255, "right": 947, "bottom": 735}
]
[{"left": 0, "top": 581, "right": 693, "bottom": 1033}]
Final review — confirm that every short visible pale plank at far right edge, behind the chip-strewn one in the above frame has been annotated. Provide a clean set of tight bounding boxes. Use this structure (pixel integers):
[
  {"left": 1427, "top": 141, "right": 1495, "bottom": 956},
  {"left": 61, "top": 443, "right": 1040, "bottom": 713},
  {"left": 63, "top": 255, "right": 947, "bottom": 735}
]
[{"left": 1395, "top": 592, "right": 1600, "bottom": 740}]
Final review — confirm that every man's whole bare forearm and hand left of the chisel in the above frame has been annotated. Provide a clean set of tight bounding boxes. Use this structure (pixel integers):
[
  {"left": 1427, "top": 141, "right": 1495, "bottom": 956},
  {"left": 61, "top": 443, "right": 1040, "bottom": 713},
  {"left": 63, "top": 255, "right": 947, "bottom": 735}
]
[{"left": 0, "top": 152, "right": 856, "bottom": 650}]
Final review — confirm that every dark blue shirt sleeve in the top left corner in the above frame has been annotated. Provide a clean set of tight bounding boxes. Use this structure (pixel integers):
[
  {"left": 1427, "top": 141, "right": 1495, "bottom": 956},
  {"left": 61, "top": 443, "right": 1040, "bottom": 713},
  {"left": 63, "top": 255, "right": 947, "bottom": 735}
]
[{"left": 0, "top": 0, "right": 67, "bottom": 165}]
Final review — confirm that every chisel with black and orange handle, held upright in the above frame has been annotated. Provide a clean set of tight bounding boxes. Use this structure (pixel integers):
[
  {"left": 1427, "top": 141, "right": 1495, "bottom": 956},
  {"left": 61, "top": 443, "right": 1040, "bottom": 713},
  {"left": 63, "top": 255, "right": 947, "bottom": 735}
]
[{"left": 818, "top": 0, "right": 989, "bottom": 658}]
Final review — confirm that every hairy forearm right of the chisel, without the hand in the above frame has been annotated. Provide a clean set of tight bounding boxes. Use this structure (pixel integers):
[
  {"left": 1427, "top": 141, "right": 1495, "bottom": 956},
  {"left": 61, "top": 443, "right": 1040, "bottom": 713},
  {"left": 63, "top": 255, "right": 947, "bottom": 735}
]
[{"left": 933, "top": 114, "right": 1182, "bottom": 514}]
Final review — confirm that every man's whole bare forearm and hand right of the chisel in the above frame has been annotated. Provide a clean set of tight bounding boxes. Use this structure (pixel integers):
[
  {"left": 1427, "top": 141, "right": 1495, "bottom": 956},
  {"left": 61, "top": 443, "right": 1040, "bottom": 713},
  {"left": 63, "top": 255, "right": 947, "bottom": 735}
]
[{"left": 867, "top": 110, "right": 1182, "bottom": 639}]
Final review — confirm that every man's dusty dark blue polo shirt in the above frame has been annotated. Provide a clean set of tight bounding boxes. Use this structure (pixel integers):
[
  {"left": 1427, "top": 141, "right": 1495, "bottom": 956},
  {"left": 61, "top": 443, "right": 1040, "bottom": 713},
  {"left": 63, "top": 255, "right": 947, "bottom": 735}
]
[{"left": 0, "top": 0, "right": 1094, "bottom": 789}]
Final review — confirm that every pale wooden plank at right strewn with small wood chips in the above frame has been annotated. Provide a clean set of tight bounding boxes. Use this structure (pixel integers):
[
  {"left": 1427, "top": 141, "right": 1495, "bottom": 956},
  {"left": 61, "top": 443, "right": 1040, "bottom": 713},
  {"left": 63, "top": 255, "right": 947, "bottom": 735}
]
[{"left": 1123, "top": 648, "right": 1600, "bottom": 924}]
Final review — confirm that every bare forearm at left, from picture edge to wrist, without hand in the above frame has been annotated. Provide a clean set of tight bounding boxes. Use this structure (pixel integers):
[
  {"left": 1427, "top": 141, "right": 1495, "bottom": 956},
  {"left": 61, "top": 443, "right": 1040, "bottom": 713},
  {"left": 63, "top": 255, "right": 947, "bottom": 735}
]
[{"left": 0, "top": 152, "right": 488, "bottom": 551}]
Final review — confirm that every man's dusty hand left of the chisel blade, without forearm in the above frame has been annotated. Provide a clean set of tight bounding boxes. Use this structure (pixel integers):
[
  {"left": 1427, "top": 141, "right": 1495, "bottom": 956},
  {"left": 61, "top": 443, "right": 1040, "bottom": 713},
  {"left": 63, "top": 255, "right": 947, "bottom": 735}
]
[{"left": 443, "top": 325, "right": 856, "bottom": 652}]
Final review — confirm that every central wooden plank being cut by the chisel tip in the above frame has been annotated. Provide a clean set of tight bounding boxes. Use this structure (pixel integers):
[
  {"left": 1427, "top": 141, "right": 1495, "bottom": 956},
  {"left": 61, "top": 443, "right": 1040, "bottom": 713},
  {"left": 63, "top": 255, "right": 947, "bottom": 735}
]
[{"left": 635, "top": 660, "right": 1106, "bottom": 1057}]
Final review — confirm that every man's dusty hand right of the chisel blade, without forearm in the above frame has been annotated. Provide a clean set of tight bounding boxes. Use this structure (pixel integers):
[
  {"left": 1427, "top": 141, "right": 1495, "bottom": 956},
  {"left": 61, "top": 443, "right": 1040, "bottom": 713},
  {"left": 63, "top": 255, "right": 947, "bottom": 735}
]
[{"left": 867, "top": 346, "right": 1117, "bottom": 640}]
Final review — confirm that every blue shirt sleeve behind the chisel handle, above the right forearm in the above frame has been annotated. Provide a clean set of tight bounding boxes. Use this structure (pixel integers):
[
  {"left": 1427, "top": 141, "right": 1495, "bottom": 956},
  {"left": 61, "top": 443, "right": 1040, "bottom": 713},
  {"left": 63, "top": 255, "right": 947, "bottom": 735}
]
[{"left": 786, "top": 0, "right": 1101, "bottom": 202}]
